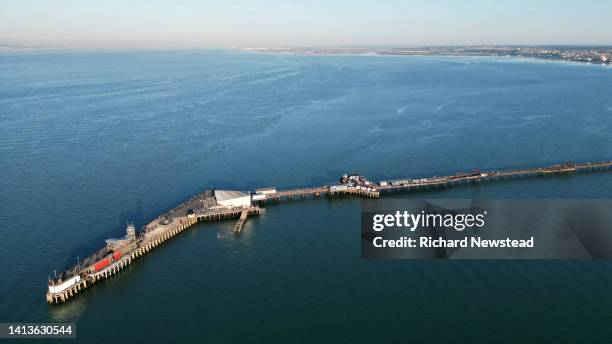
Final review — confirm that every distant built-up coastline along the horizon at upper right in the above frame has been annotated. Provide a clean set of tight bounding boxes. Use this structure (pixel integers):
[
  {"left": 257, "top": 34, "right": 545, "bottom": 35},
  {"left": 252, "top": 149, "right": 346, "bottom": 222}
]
[{"left": 242, "top": 46, "right": 612, "bottom": 65}]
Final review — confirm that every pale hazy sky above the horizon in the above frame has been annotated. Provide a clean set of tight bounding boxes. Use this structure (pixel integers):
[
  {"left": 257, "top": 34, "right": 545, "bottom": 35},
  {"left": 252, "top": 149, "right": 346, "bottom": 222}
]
[{"left": 0, "top": 0, "right": 612, "bottom": 48}]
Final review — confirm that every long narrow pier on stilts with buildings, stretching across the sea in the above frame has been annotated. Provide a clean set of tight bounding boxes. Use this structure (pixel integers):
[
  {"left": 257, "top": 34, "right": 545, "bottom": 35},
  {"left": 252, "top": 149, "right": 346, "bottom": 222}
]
[{"left": 47, "top": 161, "right": 612, "bottom": 304}]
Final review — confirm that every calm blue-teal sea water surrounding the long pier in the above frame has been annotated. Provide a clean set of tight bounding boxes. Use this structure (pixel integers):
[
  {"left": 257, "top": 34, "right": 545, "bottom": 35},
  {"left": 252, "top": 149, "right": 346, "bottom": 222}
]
[{"left": 0, "top": 51, "right": 612, "bottom": 343}]
